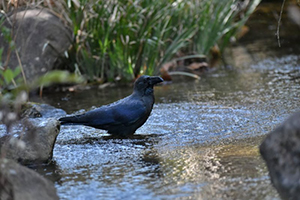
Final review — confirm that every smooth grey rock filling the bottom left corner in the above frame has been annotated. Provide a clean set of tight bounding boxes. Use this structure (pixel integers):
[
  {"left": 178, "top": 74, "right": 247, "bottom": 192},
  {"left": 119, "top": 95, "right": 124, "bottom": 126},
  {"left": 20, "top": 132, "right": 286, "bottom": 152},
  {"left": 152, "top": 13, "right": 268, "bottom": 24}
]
[{"left": 0, "top": 159, "right": 59, "bottom": 200}]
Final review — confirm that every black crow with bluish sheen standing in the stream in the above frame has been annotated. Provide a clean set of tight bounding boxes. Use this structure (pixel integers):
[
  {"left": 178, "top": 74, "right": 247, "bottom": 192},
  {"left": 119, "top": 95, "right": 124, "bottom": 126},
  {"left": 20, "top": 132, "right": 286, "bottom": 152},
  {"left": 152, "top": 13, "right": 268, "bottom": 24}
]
[{"left": 59, "top": 75, "right": 163, "bottom": 137}]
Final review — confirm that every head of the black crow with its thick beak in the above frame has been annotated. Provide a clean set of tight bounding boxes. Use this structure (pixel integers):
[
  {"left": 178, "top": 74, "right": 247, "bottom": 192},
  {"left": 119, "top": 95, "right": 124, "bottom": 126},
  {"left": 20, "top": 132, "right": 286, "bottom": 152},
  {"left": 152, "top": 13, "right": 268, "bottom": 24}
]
[{"left": 134, "top": 75, "right": 164, "bottom": 94}]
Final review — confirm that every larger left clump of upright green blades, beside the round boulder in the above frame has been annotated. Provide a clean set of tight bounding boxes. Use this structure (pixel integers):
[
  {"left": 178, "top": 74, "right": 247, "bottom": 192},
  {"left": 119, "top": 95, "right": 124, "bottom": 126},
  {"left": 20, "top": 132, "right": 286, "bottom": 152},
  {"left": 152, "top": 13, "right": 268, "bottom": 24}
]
[{"left": 71, "top": 0, "right": 199, "bottom": 80}]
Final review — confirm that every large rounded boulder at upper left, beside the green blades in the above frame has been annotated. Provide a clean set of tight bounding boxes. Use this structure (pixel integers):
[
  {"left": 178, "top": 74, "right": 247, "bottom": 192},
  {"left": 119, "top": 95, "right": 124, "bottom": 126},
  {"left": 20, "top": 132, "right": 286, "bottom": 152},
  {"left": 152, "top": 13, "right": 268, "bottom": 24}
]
[{"left": 0, "top": 8, "right": 72, "bottom": 80}]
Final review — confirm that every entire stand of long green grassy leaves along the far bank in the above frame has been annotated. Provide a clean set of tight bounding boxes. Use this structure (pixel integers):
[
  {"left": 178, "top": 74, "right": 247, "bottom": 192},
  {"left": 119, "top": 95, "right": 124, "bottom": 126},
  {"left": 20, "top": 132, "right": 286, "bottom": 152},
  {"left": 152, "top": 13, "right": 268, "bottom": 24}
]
[{"left": 68, "top": 0, "right": 260, "bottom": 80}]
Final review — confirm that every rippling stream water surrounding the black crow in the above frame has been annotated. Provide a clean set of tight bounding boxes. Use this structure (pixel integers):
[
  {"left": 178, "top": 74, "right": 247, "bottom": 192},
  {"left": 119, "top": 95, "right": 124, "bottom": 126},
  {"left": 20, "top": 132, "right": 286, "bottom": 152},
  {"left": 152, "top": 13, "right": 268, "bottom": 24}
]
[{"left": 31, "top": 1, "right": 300, "bottom": 199}]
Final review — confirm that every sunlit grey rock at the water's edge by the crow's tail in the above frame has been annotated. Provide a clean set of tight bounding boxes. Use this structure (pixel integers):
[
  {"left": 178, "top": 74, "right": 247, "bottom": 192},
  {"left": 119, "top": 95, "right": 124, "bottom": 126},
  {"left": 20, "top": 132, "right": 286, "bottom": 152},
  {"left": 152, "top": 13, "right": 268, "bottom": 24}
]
[{"left": 0, "top": 118, "right": 60, "bottom": 163}]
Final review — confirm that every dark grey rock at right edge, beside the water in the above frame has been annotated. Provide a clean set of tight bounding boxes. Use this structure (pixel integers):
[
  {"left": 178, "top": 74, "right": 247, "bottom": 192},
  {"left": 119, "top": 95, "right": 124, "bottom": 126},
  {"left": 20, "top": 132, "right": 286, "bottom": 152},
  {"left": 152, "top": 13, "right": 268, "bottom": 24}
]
[{"left": 260, "top": 112, "right": 300, "bottom": 199}]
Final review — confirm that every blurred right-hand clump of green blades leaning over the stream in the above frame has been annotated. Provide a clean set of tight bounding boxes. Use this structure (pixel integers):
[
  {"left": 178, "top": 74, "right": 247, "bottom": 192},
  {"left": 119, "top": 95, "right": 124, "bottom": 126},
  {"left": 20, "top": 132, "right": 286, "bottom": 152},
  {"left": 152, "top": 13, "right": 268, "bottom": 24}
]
[{"left": 190, "top": 0, "right": 261, "bottom": 55}]
